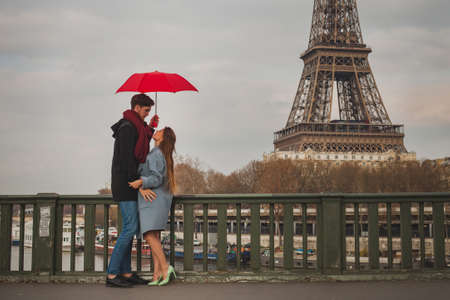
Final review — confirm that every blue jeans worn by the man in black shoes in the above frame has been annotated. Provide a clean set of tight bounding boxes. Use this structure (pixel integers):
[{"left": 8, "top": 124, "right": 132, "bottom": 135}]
[{"left": 108, "top": 201, "right": 139, "bottom": 275}]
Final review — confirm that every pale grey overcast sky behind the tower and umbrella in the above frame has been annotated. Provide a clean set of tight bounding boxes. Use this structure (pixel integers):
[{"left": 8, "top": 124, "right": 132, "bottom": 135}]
[{"left": 0, "top": 0, "right": 450, "bottom": 194}]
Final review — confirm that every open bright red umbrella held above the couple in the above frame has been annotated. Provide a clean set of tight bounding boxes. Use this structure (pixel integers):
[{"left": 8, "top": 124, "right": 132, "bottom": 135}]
[{"left": 116, "top": 71, "right": 198, "bottom": 112}]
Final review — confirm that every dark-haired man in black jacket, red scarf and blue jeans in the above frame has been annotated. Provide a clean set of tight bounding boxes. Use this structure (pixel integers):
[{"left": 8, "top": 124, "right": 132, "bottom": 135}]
[{"left": 106, "top": 94, "right": 159, "bottom": 287}]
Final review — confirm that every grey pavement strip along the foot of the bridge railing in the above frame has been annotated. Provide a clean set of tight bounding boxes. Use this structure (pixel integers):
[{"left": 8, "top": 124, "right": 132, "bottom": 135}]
[{"left": 0, "top": 280, "right": 450, "bottom": 300}]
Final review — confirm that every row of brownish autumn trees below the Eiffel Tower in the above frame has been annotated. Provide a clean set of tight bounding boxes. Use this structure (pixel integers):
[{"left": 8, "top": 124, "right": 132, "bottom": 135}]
[{"left": 175, "top": 159, "right": 450, "bottom": 194}]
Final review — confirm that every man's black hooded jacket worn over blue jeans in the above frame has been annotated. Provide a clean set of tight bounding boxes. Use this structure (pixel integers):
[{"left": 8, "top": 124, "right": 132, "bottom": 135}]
[{"left": 111, "top": 119, "right": 153, "bottom": 201}]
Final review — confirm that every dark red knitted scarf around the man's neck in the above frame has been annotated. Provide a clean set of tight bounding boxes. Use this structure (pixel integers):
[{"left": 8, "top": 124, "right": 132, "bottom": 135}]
[{"left": 123, "top": 109, "right": 154, "bottom": 163}]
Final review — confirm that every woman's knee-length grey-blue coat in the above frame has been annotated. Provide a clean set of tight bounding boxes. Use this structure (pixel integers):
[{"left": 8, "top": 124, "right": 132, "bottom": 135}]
[{"left": 138, "top": 147, "right": 173, "bottom": 234}]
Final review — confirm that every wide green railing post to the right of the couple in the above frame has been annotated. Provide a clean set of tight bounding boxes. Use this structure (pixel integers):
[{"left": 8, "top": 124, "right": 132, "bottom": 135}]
[{"left": 318, "top": 196, "right": 344, "bottom": 274}]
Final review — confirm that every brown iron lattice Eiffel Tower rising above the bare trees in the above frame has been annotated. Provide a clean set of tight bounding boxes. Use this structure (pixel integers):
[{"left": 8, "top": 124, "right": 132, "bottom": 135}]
[{"left": 274, "top": 0, "right": 407, "bottom": 157}]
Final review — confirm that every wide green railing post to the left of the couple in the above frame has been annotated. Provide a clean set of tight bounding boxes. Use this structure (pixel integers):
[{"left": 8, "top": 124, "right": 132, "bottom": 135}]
[{"left": 32, "top": 194, "right": 59, "bottom": 275}]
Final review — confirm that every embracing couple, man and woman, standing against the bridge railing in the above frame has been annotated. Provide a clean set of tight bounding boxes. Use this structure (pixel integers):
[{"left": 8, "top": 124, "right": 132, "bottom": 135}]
[{"left": 106, "top": 94, "right": 176, "bottom": 287}]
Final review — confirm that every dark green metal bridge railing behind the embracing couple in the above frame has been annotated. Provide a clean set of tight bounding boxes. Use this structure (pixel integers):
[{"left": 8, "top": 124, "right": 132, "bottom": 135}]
[{"left": 0, "top": 193, "right": 450, "bottom": 275}]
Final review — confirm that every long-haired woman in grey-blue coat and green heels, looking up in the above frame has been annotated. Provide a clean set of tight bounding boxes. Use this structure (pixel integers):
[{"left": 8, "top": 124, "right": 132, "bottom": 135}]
[{"left": 129, "top": 127, "right": 176, "bottom": 286}]
